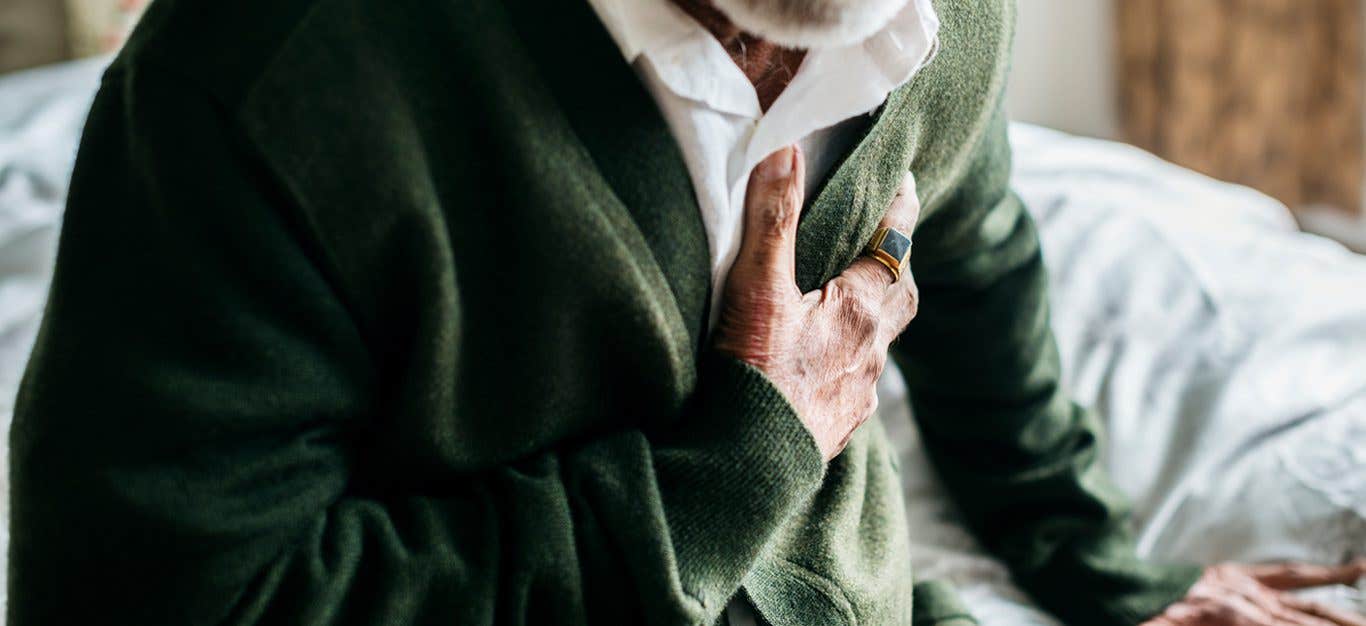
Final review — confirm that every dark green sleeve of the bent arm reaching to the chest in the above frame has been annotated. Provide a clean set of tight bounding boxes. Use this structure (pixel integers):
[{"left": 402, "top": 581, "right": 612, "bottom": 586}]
[{"left": 8, "top": 68, "right": 825, "bottom": 626}]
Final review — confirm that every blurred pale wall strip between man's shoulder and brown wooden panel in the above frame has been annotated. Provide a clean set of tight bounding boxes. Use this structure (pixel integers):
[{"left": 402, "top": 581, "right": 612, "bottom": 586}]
[{"left": 1007, "top": 0, "right": 1120, "bottom": 138}]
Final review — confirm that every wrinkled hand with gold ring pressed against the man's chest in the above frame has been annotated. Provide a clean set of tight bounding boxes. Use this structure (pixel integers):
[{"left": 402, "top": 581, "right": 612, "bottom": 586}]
[{"left": 716, "top": 146, "right": 919, "bottom": 461}]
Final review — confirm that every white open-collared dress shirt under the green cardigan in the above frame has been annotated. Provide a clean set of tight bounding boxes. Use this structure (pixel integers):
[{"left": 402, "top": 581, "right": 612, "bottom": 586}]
[{"left": 589, "top": 0, "right": 938, "bottom": 332}]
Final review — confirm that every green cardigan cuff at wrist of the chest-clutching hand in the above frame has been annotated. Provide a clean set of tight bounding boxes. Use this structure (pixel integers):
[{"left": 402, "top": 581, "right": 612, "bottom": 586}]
[{"left": 656, "top": 353, "right": 825, "bottom": 611}]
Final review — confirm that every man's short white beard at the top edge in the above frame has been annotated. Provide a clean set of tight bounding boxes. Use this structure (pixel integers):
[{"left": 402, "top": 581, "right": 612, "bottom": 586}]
[{"left": 712, "top": 0, "right": 907, "bottom": 49}]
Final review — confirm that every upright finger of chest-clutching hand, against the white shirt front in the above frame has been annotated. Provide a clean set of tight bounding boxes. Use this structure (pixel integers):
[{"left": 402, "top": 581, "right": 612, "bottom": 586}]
[{"left": 732, "top": 145, "right": 806, "bottom": 290}]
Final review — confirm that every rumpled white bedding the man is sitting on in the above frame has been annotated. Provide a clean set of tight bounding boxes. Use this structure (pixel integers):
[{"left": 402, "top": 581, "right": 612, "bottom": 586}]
[{"left": 0, "top": 60, "right": 1366, "bottom": 626}]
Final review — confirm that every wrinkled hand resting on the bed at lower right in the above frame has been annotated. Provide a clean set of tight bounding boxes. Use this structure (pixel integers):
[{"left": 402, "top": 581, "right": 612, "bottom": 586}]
[{"left": 1143, "top": 560, "right": 1366, "bottom": 626}]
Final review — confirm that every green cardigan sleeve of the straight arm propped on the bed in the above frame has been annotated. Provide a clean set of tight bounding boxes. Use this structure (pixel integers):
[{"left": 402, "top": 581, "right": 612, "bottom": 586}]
[{"left": 893, "top": 105, "right": 1199, "bottom": 626}]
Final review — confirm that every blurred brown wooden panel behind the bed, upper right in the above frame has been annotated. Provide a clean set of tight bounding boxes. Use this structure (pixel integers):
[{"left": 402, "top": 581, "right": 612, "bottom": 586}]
[{"left": 1116, "top": 0, "right": 1366, "bottom": 213}]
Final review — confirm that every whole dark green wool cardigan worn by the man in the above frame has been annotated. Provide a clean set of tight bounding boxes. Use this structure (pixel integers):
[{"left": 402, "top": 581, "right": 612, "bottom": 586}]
[{"left": 8, "top": 0, "right": 1195, "bottom": 626}]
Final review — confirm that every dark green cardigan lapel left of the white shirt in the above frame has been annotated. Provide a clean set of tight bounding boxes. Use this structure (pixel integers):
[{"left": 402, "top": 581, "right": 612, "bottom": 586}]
[{"left": 507, "top": 0, "right": 712, "bottom": 350}]
